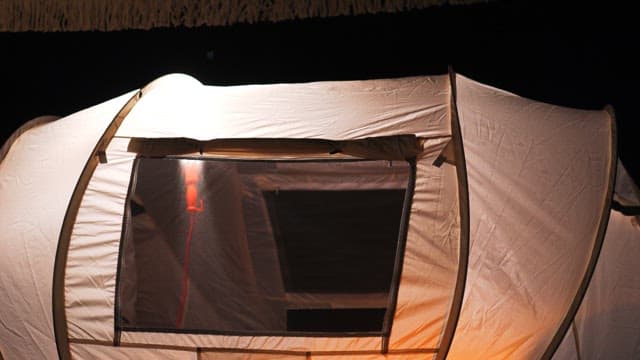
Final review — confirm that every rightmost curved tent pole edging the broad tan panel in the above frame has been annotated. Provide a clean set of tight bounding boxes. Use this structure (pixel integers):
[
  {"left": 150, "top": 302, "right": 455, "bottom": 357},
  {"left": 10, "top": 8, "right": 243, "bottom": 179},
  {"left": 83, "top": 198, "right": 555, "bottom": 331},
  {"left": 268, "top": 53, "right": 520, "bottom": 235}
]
[{"left": 540, "top": 105, "right": 618, "bottom": 360}]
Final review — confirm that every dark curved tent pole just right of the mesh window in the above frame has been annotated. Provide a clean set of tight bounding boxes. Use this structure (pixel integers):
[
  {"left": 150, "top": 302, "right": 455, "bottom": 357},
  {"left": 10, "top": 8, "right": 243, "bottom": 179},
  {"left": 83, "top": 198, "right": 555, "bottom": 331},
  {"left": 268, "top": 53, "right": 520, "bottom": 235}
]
[{"left": 435, "top": 67, "right": 470, "bottom": 360}]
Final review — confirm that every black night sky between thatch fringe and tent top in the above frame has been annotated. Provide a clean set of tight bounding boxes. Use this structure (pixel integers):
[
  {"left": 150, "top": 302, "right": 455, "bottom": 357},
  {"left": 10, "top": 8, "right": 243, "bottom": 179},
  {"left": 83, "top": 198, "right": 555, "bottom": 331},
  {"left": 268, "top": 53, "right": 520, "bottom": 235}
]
[{"left": 0, "top": 2, "right": 640, "bottom": 183}]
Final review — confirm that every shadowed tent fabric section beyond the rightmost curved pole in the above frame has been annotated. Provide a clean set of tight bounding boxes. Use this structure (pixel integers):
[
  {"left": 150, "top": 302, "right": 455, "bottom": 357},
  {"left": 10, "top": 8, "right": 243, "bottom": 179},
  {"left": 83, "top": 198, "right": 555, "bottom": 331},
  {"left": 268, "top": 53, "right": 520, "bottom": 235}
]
[{"left": 554, "top": 211, "right": 640, "bottom": 360}]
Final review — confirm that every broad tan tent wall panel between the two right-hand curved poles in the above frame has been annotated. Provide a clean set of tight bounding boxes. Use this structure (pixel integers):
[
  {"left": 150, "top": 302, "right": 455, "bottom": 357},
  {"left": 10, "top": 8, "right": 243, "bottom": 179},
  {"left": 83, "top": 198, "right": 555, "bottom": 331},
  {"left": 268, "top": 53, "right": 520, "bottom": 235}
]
[{"left": 449, "top": 77, "right": 615, "bottom": 359}]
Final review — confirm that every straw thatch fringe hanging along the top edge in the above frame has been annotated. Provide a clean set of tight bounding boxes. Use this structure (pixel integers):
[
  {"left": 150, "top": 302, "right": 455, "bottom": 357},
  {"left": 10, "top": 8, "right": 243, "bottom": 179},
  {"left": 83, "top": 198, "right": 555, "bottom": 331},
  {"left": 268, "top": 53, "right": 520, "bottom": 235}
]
[{"left": 0, "top": 0, "right": 486, "bottom": 32}]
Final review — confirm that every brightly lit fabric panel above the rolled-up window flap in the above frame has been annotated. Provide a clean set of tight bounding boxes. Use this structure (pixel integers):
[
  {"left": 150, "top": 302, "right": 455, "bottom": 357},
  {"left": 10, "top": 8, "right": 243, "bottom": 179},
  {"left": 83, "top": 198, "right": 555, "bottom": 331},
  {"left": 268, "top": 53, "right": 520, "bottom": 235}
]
[{"left": 117, "top": 75, "right": 450, "bottom": 141}]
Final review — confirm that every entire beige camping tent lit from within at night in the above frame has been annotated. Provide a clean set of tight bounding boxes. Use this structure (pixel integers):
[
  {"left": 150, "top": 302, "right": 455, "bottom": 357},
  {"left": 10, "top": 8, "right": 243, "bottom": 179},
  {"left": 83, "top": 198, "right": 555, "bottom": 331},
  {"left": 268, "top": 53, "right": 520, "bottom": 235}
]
[{"left": 0, "top": 73, "right": 640, "bottom": 360}]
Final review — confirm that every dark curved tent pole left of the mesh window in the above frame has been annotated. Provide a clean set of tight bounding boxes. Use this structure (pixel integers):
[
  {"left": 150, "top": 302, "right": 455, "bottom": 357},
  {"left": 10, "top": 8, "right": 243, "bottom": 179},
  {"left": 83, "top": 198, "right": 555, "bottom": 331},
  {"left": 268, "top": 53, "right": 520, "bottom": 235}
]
[{"left": 52, "top": 89, "right": 144, "bottom": 360}]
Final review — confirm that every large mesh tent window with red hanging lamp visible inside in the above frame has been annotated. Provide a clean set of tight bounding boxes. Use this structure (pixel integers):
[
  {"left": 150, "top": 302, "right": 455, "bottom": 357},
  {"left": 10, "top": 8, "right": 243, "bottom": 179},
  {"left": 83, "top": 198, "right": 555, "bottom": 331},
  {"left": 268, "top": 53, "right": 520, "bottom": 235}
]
[{"left": 116, "top": 157, "right": 413, "bottom": 336}]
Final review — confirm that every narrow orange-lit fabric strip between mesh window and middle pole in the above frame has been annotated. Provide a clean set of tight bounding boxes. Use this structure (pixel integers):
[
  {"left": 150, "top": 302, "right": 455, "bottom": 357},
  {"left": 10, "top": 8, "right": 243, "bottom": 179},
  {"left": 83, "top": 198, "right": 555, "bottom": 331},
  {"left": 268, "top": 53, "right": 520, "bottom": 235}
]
[{"left": 389, "top": 154, "right": 460, "bottom": 350}]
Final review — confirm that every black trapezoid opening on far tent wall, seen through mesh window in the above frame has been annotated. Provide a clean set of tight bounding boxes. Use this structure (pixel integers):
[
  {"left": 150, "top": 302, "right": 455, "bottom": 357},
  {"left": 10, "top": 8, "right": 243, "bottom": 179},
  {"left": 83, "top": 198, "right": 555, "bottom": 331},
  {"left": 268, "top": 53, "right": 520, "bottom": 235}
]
[{"left": 264, "top": 190, "right": 404, "bottom": 293}]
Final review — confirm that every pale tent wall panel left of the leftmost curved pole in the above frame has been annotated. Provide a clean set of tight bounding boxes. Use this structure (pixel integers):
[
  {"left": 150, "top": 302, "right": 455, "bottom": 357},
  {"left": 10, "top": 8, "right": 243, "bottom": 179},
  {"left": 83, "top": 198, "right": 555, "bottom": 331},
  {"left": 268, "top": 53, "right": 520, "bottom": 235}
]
[{"left": 0, "top": 94, "right": 131, "bottom": 359}]
